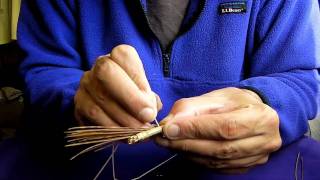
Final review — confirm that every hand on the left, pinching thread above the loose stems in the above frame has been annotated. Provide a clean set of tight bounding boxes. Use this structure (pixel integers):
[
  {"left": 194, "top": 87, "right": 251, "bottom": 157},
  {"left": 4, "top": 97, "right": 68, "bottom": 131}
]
[{"left": 74, "top": 45, "right": 162, "bottom": 127}]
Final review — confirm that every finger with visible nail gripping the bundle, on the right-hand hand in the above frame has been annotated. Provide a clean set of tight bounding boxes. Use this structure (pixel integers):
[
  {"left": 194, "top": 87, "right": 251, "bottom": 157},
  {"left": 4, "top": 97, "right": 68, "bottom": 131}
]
[{"left": 164, "top": 105, "right": 278, "bottom": 140}]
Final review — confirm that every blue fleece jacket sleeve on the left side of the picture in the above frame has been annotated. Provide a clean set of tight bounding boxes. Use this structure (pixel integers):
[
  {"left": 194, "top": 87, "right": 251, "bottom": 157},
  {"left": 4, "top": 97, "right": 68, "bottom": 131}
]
[{"left": 18, "top": 0, "right": 83, "bottom": 126}]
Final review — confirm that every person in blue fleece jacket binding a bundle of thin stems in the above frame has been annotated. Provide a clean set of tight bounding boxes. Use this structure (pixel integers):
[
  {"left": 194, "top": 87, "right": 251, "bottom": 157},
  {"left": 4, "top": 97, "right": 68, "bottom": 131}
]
[{"left": 10, "top": 0, "right": 320, "bottom": 179}]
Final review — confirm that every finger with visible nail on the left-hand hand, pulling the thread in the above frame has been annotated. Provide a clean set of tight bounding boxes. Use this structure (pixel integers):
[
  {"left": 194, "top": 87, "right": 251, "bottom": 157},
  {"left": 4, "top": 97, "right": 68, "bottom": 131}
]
[{"left": 90, "top": 56, "right": 157, "bottom": 122}]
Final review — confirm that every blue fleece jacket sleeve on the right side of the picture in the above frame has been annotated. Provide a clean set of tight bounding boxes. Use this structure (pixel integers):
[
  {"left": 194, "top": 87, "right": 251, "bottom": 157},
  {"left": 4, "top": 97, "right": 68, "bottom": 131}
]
[{"left": 240, "top": 0, "right": 320, "bottom": 145}]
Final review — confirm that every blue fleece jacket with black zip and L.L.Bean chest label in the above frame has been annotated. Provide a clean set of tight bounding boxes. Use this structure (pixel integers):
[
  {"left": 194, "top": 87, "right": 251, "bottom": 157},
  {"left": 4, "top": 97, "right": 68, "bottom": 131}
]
[{"left": 18, "top": 0, "right": 320, "bottom": 177}]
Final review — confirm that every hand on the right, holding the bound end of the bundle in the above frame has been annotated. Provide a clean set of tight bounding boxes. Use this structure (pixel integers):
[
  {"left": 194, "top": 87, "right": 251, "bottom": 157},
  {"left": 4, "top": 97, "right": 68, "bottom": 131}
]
[{"left": 156, "top": 88, "right": 282, "bottom": 172}]
